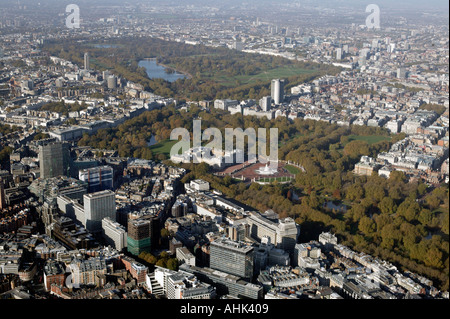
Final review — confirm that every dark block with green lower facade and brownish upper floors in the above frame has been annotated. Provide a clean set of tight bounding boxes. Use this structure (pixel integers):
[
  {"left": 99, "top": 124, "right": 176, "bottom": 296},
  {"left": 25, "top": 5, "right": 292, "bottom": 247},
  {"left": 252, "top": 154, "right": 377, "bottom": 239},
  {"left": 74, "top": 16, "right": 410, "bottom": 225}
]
[{"left": 127, "top": 219, "right": 151, "bottom": 256}]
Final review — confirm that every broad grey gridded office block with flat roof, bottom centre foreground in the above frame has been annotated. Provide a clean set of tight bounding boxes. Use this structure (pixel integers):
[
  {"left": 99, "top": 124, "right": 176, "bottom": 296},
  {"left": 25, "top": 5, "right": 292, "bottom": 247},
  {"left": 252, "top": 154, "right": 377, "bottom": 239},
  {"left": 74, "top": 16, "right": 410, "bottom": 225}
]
[{"left": 210, "top": 238, "right": 253, "bottom": 280}]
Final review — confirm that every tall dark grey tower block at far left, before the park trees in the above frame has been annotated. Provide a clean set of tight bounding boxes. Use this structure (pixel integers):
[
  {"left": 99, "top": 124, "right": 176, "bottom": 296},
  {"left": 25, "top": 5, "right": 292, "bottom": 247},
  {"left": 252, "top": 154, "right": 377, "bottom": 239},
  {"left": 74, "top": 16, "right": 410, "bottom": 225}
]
[{"left": 39, "top": 142, "right": 70, "bottom": 178}]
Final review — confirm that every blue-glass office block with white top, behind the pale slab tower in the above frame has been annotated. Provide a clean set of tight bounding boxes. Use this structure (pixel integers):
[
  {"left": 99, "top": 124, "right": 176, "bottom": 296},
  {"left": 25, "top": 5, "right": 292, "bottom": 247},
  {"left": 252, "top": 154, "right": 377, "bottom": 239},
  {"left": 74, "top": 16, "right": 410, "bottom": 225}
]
[{"left": 78, "top": 166, "right": 114, "bottom": 193}]
